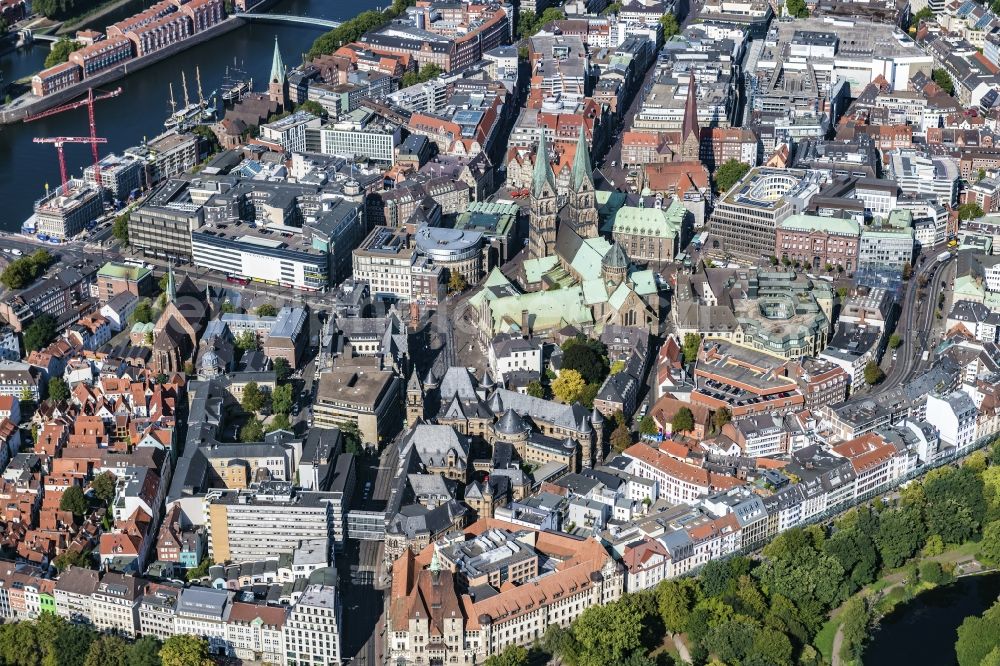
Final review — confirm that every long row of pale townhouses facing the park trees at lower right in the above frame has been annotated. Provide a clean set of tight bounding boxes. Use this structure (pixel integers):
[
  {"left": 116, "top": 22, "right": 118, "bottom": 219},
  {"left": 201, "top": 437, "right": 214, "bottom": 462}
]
[{"left": 604, "top": 421, "right": 938, "bottom": 592}]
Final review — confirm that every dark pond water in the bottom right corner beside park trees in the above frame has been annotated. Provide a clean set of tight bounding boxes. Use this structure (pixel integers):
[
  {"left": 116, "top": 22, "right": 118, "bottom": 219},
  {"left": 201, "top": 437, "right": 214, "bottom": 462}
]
[{"left": 864, "top": 573, "right": 1000, "bottom": 666}]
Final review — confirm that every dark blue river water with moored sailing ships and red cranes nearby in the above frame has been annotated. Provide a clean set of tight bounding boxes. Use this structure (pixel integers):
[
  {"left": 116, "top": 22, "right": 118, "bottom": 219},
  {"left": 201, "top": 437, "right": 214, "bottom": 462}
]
[{"left": 0, "top": 0, "right": 387, "bottom": 231}]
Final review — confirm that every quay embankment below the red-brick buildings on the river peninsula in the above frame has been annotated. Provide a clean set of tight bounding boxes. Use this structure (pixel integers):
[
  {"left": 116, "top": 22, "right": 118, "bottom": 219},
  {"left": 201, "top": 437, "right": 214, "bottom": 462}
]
[{"left": 0, "top": 16, "right": 246, "bottom": 125}]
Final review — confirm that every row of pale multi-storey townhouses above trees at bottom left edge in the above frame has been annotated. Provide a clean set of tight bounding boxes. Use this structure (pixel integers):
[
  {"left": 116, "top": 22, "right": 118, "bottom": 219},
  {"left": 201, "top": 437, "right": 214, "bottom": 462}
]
[{"left": 0, "top": 564, "right": 342, "bottom": 666}]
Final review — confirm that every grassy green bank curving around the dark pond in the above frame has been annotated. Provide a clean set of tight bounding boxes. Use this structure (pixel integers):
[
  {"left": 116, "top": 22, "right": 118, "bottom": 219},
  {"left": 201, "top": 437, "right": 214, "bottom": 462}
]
[{"left": 814, "top": 541, "right": 998, "bottom": 666}]
